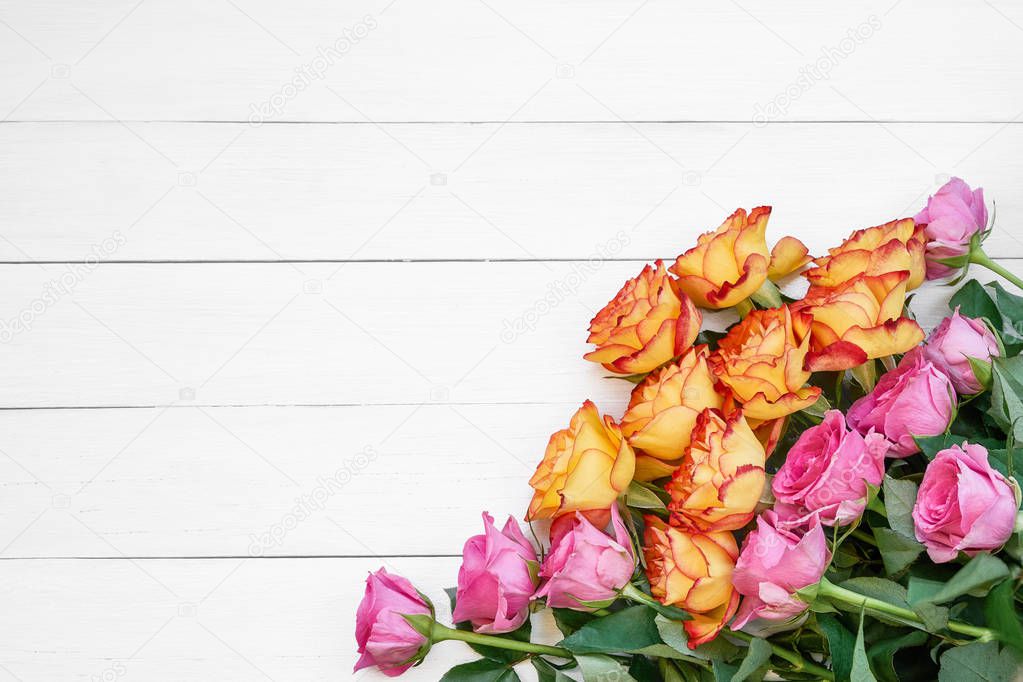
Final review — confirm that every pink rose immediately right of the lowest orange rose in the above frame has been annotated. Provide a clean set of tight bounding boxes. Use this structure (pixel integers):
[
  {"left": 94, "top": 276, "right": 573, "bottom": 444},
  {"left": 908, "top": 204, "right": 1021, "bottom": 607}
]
[{"left": 731, "top": 509, "right": 831, "bottom": 630}]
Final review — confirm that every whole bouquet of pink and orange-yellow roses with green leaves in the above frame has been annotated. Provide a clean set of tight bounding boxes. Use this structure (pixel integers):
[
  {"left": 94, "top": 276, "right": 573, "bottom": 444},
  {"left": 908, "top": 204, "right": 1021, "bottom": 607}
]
[{"left": 356, "top": 179, "right": 1023, "bottom": 682}]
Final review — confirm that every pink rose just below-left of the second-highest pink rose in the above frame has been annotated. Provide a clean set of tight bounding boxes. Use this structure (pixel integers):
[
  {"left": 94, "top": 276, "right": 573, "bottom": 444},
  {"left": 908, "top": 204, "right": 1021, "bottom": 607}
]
[{"left": 847, "top": 349, "right": 955, "bottom": 457}]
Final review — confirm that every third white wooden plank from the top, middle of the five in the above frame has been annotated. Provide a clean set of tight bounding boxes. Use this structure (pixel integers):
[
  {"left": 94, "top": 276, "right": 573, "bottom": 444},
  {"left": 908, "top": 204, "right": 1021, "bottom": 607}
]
[{"left": 0, "top": 261, "right": 1020, "bottom": 411}]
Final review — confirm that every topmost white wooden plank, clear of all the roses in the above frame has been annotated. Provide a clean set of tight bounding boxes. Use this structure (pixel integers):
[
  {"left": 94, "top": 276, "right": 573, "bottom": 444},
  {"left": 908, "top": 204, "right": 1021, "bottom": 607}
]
[{"left": 0, "top": 0, "right": 1023, "bottom": 121}]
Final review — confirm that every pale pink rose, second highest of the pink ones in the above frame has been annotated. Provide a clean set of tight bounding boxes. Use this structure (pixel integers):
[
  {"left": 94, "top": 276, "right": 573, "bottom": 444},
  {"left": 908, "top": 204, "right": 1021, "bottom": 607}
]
[{"left": 924, "top": 308, "right": 999, "bottom": 396}]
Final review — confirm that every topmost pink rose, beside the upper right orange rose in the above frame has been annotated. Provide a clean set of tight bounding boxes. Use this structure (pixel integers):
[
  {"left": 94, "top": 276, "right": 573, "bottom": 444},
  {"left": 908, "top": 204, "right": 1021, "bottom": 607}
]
[{"left": 914, "top": 178, "right": 987, "bottom": 279}]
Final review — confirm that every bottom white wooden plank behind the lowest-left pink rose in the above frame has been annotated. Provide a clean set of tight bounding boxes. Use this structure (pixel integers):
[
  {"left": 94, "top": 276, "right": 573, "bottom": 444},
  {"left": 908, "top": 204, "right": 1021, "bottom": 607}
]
[{"left": 0, "top": 558, "right": 559, "bottom": 682}]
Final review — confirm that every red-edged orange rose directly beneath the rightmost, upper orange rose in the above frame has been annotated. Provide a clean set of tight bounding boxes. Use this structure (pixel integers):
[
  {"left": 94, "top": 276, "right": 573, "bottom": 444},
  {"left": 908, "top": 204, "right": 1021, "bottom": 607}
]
[{"left": 793, "top": 270, "right": 924, "bottom": 371}]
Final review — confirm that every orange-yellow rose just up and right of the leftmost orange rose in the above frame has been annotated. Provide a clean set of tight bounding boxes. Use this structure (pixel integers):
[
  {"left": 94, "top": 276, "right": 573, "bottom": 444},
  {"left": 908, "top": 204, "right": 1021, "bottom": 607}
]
[{"left": 622, "top": 346, "right": 724, "bottom": 481}]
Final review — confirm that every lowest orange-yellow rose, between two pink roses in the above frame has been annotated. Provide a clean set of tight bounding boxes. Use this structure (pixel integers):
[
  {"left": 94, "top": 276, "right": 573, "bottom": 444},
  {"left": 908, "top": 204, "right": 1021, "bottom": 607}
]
[{"left": 643, "top": 516, "right": 739, "bottom": 649}]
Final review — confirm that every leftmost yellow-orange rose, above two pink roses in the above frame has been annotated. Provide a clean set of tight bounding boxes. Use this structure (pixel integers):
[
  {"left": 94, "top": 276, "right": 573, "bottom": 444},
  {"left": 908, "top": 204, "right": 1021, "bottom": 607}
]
[{"left": 526, "top": 400, "right": 635, "bottom": 520}]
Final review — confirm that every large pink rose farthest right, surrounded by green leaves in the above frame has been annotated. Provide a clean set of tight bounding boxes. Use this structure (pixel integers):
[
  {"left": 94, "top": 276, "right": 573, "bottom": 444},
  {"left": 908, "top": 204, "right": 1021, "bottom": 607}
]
[{"left": 913, "top": 443, "right": 1019, "bottom": 563}]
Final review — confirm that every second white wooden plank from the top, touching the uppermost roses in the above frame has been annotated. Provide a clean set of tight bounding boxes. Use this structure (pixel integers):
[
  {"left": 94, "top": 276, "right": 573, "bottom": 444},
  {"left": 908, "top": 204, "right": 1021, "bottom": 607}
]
[{"left": 6, "top": 122, "right": 1023, "bottom": 261}]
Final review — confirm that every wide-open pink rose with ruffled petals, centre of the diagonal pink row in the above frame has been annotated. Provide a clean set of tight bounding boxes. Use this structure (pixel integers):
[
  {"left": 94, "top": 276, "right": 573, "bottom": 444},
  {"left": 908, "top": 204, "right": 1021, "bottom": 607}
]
[{"left": 771, "top": 410, "right": 890, "bottom": 526}]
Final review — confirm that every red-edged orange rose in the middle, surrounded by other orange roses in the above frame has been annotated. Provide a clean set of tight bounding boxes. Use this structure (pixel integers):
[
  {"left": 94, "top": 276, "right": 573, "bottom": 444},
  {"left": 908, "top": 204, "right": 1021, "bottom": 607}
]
[{"left": 710, "top": 306, "right": 820, "bottom": 420}]
